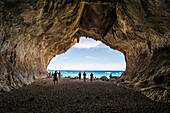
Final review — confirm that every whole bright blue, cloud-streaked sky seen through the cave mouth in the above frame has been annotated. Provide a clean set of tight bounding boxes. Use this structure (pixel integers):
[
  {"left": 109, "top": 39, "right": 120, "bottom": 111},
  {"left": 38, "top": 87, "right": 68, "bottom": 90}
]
[{"left": 47, "top": 37, "right": 126, "bottom": 71}]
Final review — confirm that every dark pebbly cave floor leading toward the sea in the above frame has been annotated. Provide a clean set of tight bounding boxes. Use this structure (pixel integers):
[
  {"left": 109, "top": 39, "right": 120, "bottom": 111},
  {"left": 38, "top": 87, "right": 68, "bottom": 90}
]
[{"left": 0, "top": 78, "right": 170, "bottom": 113}]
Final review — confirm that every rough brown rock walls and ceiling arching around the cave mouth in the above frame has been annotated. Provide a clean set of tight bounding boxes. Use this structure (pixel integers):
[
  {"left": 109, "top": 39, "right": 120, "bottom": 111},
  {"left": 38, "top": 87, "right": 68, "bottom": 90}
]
[{"left": 0, "top": 0, "right": 170, "bottom": 102}]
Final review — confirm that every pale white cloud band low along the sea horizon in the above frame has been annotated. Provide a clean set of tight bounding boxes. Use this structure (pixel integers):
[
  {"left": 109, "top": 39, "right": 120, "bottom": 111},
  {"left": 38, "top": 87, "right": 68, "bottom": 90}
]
[{"left": 48, "top": 64, "right": 126, "bottom": 70}]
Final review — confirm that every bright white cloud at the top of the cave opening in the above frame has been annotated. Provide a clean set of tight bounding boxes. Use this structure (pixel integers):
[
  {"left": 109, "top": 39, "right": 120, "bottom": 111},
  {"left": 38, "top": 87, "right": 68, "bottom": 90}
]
[{"left": 73, "top": 37, "right": 107, "bottom": 49}]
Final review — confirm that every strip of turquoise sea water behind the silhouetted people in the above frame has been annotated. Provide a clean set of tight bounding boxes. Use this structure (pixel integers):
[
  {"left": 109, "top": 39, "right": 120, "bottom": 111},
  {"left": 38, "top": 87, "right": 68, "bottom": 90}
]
[{"left": 48, "top": 70, "right": 124, "bottom": 78}]
